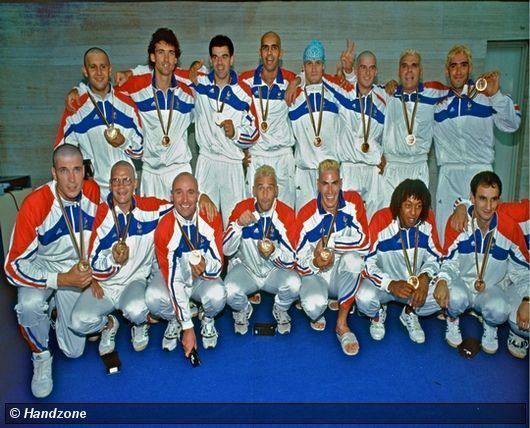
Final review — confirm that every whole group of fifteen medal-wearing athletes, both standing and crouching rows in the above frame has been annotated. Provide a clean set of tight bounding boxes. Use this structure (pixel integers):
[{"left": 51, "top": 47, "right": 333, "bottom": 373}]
[{"left": 5, "top": 28, "right": 530, "bottom": 397}]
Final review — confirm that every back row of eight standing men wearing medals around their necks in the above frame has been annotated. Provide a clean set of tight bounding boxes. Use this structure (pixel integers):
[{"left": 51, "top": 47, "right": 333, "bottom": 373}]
[{"left": 56, "top": 28, "right": 521, "bottom": 237}]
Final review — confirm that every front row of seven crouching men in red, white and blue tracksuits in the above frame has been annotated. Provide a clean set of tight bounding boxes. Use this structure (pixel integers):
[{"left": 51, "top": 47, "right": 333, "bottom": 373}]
[{"left": 5, "top": 144, "right": 530, "bottom": 397}]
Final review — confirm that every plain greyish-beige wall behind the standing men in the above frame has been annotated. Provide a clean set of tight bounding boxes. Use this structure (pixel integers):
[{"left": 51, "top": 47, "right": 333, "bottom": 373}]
[{"left": 0, "top": 2, "right": 528, "bottom": 196}]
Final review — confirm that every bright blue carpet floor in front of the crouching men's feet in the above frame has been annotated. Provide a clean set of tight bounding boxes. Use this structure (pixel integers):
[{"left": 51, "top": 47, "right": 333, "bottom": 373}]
[{"left": 0, "top": 280, "right": 529, "bottom": 426}]
